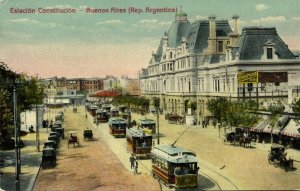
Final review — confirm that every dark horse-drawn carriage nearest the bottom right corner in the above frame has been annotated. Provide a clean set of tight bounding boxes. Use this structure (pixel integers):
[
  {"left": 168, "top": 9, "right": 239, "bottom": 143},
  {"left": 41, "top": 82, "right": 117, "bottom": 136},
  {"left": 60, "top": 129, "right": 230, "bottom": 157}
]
[{"left": 268, "top": 144, "right": 294, "bottom": 171}]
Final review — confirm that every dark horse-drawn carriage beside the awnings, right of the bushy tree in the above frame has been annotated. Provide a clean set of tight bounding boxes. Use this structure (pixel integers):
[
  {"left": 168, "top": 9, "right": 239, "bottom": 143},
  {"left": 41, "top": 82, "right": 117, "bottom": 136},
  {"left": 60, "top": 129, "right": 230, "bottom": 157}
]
[{"left": 224, "top": 128, "right": 252, "bottom": 147}]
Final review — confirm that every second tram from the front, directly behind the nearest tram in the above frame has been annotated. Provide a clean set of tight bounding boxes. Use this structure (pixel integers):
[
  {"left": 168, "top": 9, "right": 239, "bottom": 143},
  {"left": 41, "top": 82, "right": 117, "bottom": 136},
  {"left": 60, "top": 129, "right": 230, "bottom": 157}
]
[{"left": 126, "top": 127, "right": 152, "bottom": 158}]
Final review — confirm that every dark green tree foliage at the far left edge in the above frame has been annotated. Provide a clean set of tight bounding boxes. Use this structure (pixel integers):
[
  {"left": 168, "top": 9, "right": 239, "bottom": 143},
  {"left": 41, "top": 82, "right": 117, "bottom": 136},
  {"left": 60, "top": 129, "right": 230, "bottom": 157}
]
[{"left": 0, "top": 62, "right": 44, "bottom": 138}]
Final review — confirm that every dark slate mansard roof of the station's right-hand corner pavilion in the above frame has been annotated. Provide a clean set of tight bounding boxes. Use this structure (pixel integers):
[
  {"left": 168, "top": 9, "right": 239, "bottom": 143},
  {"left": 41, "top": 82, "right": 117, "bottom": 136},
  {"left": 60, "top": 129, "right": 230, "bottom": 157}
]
[{"left": 237, "top": 27, "right": 295, "bottom": 60}]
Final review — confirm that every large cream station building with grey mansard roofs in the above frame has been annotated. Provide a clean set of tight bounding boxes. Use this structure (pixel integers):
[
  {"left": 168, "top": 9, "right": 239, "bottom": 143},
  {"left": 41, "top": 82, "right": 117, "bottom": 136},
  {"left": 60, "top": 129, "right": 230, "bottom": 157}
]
[{"left": 140, "top": 11, "right": 300, "bottom": 121}]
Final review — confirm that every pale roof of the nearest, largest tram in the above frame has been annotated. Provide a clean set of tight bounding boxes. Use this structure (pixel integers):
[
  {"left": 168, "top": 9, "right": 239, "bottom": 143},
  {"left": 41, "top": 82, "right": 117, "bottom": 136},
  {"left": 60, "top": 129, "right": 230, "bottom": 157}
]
[{"left": 152, "top": 145, "right": 198, "bottom": 163}]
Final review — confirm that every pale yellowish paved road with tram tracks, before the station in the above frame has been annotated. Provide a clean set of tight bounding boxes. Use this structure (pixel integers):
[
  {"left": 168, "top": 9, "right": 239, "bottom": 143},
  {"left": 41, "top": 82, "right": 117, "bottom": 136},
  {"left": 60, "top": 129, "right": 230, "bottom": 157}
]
[{"left": 84, "top": 106, "right": 300, "bottom": 190}]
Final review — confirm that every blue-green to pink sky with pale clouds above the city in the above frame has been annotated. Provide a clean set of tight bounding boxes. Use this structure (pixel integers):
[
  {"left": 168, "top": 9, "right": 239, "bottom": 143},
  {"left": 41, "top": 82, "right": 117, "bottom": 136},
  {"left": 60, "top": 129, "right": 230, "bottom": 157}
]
[{"left": 0, "top": 0, "right": 300, "bottom": 78}]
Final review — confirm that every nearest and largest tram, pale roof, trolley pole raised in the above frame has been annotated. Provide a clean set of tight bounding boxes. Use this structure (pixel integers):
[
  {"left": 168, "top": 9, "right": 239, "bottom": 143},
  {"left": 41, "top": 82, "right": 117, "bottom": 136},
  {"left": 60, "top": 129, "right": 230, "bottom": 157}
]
[{"left": 151, "top": 145, "right": 199, "bottom": 189}]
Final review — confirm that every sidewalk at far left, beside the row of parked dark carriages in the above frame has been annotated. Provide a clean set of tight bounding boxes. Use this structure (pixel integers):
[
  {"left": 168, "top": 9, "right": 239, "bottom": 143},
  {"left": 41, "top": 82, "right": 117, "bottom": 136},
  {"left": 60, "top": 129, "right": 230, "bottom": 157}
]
[{"left": 0, "top": 129, "right": 47, "bottom": 191}]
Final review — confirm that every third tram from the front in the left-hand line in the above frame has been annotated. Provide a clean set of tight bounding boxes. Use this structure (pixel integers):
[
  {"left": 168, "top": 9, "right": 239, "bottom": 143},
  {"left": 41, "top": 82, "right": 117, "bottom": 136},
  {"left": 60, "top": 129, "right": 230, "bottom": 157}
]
[{"left": 108, "top": 117, "right": 127, "bottom": 137}]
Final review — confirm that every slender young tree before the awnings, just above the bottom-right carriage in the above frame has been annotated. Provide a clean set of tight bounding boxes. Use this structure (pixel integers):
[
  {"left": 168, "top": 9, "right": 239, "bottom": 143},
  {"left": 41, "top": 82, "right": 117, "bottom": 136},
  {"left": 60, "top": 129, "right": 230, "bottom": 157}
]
[{"left": 267, "top": 102, "right": 285, "bottom": 144}]
